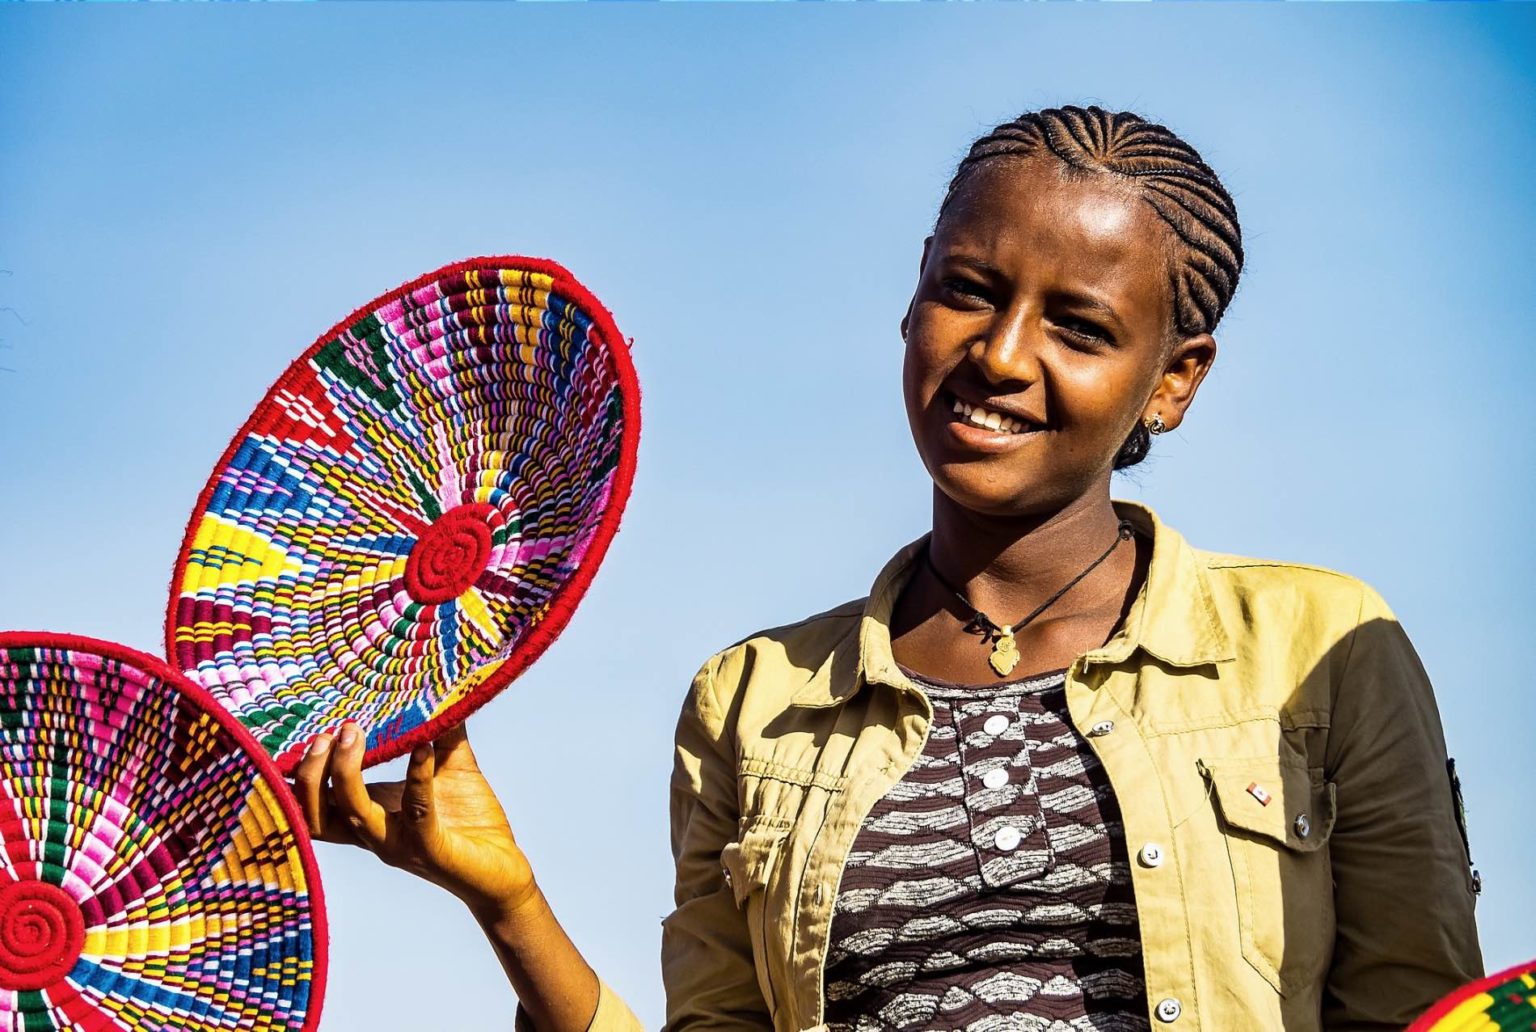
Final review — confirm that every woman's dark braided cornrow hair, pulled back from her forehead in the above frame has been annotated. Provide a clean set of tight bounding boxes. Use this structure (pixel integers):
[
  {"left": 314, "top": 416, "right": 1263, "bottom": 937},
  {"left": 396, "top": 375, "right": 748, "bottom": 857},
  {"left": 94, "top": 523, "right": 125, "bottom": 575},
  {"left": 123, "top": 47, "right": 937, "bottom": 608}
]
[{"left": 938, "top": 106, "right": 1243, "bottom": 470}]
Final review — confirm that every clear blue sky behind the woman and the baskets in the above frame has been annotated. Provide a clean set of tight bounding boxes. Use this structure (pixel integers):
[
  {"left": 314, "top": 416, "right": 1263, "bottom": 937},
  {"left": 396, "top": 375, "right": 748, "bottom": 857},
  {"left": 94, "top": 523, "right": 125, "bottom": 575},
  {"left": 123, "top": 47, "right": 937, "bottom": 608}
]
[{"left": 0, "top": 5, "right": 1536, "bottom": 1030}]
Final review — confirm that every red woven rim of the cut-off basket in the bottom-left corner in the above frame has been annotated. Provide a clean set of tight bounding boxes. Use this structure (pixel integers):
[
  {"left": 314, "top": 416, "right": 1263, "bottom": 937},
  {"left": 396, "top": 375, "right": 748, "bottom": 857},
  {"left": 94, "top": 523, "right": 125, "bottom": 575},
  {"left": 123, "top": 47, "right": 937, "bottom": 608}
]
[{"left": 0, "top": 631, "right": 330, "bottom": 1032}]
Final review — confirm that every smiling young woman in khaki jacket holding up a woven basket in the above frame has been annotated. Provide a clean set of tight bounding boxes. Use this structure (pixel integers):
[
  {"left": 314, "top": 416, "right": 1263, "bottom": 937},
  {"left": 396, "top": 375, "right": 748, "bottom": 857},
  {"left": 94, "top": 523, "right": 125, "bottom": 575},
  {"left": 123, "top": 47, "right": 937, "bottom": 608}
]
[{"left": 296, "top": 108, "right": 1481, "bottom": 1032}]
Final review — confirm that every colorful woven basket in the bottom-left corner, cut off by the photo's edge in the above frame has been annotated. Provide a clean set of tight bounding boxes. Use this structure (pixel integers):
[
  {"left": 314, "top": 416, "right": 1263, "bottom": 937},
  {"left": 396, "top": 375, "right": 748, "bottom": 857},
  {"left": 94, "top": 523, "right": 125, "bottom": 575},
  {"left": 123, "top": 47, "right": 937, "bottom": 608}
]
[{"left": 0, "top": 634, "right": 326, "bottom": 1032}]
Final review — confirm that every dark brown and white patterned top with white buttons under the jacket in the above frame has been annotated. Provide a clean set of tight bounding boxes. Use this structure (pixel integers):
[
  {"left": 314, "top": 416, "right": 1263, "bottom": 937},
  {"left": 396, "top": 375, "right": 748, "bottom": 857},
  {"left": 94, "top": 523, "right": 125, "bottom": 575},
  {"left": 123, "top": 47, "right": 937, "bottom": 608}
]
[{"left": 825, "top": 671, "right": 1149, "bottom": 1032}]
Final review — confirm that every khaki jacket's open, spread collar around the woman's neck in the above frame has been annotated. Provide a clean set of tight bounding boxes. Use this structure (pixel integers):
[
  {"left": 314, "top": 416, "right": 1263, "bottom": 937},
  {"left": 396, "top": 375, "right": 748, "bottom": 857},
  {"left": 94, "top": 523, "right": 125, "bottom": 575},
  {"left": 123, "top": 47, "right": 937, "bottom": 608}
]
[{"left": 793, "top": 499, "right": 1233, "bottom": 706}]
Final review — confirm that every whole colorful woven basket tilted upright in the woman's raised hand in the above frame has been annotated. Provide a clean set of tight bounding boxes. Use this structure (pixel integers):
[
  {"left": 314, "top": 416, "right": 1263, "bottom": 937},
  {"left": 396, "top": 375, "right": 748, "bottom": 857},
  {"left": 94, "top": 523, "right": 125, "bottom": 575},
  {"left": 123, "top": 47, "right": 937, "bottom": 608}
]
[{"left": 166, "top": 256, "right": 639, "bottom": 772}]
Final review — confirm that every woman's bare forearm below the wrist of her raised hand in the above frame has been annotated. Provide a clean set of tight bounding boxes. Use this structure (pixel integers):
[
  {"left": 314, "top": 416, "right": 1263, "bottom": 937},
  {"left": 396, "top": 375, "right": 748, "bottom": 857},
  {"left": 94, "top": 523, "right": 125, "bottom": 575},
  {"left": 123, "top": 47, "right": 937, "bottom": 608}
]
[{"left": 475, "top": 888, "right": 599, "bottom": 1032}]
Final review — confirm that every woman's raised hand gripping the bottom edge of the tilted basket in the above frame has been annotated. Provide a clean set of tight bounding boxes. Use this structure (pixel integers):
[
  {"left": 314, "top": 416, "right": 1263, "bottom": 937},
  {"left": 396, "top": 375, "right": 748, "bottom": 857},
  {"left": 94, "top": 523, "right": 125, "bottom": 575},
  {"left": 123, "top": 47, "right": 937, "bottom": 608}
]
[{"left": 293, "top": 722, "right": 538, "bottom": 920}]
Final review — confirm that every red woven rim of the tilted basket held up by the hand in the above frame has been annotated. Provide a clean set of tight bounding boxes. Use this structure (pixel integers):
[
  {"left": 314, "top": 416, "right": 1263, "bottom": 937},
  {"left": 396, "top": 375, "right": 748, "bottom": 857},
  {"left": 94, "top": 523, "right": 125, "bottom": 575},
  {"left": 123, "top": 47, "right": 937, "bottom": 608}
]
[{"left": 166, "top": 255, "right": 641, "bottom": 774}]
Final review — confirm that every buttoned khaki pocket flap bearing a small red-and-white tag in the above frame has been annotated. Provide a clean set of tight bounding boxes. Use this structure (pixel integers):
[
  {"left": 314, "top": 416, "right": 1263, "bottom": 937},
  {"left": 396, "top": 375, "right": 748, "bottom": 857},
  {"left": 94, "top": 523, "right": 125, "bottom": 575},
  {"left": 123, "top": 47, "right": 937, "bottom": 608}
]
[{"left": 1201, "top": 759, "right": 1335, "bottom": 852}]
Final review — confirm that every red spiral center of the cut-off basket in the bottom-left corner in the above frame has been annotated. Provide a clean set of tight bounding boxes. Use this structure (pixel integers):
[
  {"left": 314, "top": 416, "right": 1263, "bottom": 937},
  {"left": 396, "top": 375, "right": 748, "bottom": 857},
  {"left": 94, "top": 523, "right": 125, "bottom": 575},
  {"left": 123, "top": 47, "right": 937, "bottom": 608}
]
[{"left": 0, "top": 882, "right": 86, "bottom": 991}]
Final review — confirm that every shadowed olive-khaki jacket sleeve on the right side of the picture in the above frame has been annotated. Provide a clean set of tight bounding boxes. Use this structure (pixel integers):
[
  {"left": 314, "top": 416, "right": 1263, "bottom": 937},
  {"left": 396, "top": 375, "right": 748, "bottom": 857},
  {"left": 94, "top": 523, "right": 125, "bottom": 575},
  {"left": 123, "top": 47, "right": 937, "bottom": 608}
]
[{"left": 1322, "top": 585, "right": 1482, "bottom": 1029}]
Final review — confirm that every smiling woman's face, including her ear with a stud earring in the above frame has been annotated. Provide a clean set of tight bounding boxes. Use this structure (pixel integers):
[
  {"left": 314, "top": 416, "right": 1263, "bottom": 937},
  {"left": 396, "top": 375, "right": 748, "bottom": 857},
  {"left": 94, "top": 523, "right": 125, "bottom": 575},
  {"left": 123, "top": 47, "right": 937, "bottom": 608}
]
[{"left": 902, "top": 158, "right": 1215, "bottom": 516}]
